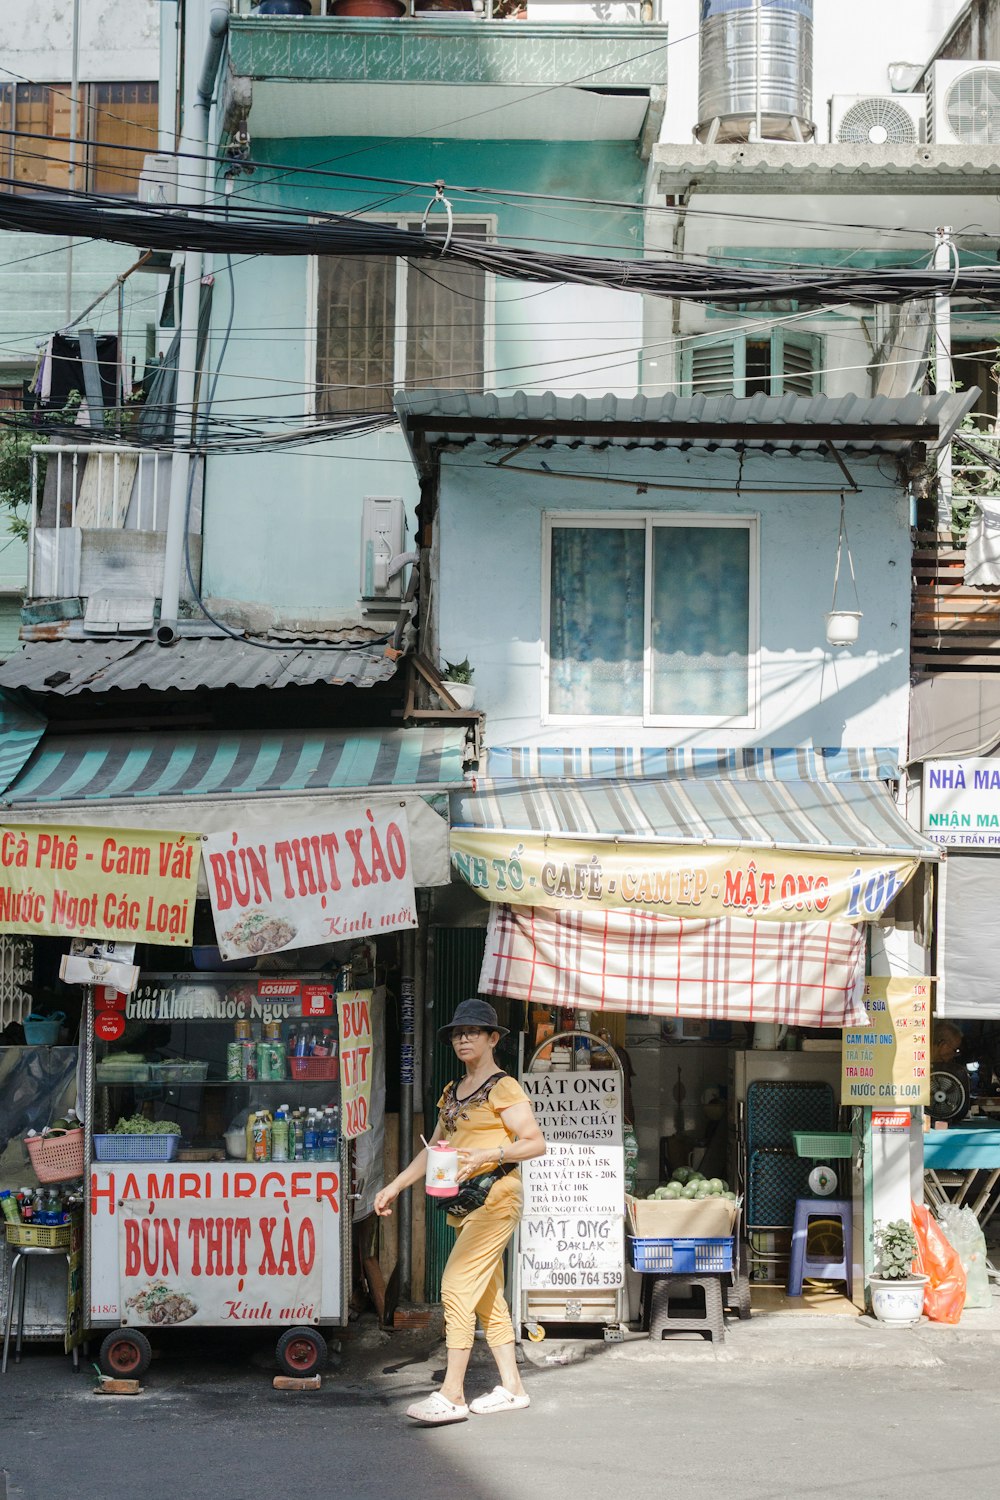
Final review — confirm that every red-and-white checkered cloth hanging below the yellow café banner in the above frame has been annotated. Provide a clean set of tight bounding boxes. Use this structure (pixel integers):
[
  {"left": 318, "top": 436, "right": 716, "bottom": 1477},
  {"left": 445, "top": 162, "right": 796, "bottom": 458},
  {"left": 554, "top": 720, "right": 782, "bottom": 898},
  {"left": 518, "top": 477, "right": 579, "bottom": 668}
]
[{"left": 480, "top": 905, "right": 868, "bottom": 1026}]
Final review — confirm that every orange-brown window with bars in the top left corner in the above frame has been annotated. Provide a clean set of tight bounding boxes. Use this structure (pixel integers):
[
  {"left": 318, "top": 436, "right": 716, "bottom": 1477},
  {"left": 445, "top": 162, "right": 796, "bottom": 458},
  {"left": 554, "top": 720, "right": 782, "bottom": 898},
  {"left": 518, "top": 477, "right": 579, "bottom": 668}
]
[{"left": 0, "top": 83, "right": 157, "bottom": 198}]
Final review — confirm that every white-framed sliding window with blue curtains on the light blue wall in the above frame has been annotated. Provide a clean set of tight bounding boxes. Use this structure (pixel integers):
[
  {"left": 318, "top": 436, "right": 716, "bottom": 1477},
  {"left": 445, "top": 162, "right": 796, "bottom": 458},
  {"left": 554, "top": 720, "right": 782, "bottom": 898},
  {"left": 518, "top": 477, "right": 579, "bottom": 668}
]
[{"left": 541, "top": 512, "right": 759, "bottom": 728}]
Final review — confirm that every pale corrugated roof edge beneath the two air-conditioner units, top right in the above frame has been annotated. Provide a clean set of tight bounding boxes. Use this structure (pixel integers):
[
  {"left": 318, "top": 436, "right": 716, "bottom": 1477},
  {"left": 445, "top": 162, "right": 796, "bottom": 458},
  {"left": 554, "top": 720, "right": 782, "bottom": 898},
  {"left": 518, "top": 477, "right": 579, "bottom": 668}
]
[{"left": 652, "top": 141, "right": 1000, "bottom": 197}]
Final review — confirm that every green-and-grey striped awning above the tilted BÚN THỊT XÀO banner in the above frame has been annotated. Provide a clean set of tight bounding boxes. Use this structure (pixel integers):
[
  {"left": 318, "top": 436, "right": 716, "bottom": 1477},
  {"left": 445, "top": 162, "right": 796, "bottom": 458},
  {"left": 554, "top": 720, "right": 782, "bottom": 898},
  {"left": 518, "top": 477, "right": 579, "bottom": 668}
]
[{"left": 1, "top": 726, "right": 465, "bottom": 818}]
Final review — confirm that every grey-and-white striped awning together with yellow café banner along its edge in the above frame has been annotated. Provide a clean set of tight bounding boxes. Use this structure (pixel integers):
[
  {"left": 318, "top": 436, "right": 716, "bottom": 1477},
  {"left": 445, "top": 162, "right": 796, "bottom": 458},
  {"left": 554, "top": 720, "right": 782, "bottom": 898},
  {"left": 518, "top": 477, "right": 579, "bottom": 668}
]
[{"left": 451, "top": 777, "right": 939, "bottom": 923}]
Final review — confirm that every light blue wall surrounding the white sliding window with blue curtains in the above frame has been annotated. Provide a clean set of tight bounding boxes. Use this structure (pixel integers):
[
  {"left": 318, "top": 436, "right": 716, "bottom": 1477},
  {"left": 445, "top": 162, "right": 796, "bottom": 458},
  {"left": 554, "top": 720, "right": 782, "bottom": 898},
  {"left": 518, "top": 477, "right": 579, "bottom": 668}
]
[{"left": 436, "top": 449, "right": 910, "bottom": 747}]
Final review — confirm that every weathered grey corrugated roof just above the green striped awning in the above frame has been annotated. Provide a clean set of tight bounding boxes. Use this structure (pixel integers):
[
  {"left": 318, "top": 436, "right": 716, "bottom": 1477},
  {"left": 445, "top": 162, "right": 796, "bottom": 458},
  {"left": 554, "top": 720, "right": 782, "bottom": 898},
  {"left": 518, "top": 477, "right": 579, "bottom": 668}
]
[{"left": 0, "top": 636, "right": 397, "bottom": 698}]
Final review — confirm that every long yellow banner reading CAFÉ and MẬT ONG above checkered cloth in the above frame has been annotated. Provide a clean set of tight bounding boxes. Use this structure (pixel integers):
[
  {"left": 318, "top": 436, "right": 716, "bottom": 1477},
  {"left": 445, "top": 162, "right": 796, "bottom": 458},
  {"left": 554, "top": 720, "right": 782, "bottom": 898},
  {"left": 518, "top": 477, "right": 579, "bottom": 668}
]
[{"left": 451, "top": 828, "right": 919, "bottom": 923}]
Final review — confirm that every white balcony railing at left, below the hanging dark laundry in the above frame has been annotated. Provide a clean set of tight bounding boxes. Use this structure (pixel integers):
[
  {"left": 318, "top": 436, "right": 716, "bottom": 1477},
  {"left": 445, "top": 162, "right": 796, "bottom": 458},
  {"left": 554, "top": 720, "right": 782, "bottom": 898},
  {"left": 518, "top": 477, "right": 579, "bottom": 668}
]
[{"left": 28, "top": 443, "right": 202, "bottom": 599}]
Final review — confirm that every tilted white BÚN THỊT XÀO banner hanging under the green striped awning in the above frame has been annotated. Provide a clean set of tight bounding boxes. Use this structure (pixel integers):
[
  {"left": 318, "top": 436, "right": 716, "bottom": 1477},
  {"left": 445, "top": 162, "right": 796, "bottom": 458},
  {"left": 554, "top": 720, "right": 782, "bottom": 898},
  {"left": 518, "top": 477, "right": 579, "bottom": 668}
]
[{"left": 204, "top": 803, "right": 417, "bottom": 960}]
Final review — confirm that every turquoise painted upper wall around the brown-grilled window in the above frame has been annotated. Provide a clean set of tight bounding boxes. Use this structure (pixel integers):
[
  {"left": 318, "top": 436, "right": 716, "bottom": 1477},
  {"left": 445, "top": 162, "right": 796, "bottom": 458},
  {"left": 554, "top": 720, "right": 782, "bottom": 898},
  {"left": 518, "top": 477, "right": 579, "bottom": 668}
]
[{"left": 204, "top": 140, "right": 643, "bottom": 629}]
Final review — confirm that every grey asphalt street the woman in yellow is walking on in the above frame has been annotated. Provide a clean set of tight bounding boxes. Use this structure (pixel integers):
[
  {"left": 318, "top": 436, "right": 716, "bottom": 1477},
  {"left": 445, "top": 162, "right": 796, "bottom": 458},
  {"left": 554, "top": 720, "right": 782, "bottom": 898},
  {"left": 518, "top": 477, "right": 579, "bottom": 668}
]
[{"left": 0, "top": 1302, "right": 1000, "bottom": 1500}]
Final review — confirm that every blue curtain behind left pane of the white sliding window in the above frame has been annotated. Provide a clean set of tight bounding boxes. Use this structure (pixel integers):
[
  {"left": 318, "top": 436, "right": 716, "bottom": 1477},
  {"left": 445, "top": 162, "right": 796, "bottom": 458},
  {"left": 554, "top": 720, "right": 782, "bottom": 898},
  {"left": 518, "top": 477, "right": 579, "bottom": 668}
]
[{"left": 549, "top": 527, "right": 645, "bottom": 717}]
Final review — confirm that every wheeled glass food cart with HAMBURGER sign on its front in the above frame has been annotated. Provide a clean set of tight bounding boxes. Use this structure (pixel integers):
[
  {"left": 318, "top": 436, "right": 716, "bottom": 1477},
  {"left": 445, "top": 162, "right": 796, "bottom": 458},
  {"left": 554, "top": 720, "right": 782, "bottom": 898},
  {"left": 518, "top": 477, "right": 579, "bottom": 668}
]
[{"left": 84, "top": 969, "right": 365, "bottom": 1376}]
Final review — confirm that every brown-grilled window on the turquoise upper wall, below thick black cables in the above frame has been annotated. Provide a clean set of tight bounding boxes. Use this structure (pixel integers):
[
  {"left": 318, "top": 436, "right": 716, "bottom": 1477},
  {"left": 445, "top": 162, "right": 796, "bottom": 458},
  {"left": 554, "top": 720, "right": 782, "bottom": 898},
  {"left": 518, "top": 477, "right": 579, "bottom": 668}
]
[{"left": 309, "top": 216, "right": 495, "bottom": 414}]
